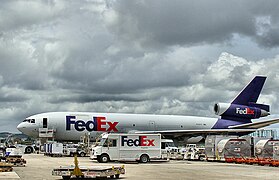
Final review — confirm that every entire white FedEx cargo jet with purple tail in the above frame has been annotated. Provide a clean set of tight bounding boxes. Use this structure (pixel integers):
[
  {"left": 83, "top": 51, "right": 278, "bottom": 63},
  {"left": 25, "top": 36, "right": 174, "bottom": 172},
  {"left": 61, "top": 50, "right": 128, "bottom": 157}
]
[{"left": 17, "top": 76, "right": 279, "bottom": 141}]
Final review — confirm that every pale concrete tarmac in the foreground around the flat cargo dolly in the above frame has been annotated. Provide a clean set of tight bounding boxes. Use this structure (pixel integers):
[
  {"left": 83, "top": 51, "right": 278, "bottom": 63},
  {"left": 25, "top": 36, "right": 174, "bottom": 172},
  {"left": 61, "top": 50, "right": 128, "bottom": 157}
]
[{"left": 0, "top": 154, "right": 279, "bottom": 180}]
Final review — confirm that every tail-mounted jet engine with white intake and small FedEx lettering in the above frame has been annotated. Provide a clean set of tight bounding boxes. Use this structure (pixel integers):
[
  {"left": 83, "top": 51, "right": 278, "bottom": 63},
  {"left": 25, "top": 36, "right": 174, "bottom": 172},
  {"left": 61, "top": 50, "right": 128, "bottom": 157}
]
[{"left": 214, "top": 103, "right": 269, "bottom": 119}]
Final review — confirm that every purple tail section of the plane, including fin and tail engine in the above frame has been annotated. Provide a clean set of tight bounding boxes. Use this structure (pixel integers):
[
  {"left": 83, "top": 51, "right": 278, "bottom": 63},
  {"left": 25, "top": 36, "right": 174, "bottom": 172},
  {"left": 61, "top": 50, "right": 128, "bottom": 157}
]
[{"left": 213, "top": 76, "right": 269, "bottom": 129}]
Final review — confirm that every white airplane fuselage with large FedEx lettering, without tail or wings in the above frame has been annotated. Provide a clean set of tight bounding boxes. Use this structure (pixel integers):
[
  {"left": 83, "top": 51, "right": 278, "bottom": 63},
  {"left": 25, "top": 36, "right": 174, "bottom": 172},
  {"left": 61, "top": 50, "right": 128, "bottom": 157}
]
[{"left": 17, "top": 112, "right": 218, "bottom": 141}]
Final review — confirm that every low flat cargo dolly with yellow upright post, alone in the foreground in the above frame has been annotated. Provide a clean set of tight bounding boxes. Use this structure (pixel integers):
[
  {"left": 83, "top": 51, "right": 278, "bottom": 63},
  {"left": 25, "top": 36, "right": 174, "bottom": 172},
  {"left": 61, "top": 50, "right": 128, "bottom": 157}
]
[{"left": 52, "top": 155, "right": 125, "bottom": 179}]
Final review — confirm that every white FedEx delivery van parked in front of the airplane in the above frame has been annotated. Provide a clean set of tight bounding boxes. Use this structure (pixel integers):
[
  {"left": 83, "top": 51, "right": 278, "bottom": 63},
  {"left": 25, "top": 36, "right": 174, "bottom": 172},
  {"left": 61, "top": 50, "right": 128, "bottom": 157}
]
[{"left": 90, "top": 133, "right": 161, "bottom": 163}]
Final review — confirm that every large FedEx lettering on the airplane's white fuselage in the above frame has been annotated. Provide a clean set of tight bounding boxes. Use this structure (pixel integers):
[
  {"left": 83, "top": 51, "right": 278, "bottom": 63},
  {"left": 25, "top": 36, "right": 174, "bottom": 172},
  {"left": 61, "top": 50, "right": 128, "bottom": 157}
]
[{"left": 66, "top": 116, "right": 118, "bottom": 132}]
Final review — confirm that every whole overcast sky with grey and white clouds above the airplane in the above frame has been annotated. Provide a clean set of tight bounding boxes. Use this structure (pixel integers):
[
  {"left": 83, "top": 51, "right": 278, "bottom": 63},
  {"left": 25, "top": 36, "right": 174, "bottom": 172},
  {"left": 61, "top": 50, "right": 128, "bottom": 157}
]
[{"left": 0, "top": 0, "right": 279, "bottom": 132}]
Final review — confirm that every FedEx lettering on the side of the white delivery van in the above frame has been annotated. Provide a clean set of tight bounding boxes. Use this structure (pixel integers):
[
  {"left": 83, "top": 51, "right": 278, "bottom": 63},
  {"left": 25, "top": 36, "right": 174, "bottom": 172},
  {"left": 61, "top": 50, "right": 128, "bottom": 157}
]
[{"left": 121, "top": 136, "right": 155, "bottom": 147}]
